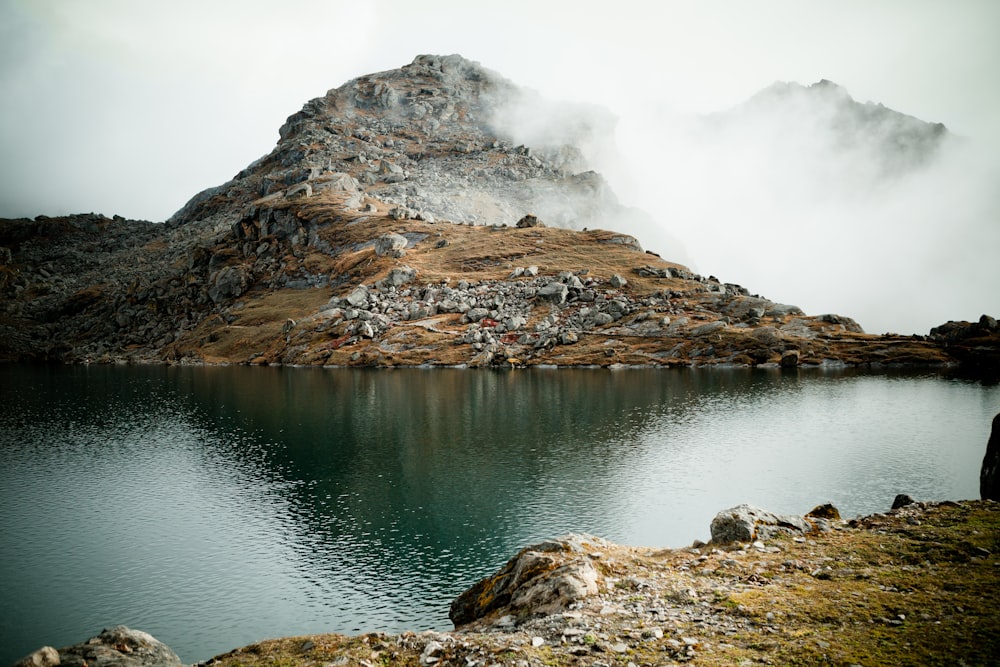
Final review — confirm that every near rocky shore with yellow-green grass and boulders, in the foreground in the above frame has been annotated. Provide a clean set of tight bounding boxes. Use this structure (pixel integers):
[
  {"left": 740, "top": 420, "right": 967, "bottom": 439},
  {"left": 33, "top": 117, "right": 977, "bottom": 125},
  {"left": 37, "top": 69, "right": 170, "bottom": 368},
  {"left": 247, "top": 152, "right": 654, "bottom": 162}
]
[{"left": 18, "top": 496, "right": 1000, "bottom": 667}]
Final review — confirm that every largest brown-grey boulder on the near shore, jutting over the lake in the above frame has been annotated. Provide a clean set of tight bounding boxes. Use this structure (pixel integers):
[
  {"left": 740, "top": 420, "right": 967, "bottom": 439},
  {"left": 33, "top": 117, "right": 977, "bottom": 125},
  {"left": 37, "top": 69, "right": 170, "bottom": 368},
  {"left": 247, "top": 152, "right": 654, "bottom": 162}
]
[{"left": 448, "top": 535, "right": 607, "bottom": 627}]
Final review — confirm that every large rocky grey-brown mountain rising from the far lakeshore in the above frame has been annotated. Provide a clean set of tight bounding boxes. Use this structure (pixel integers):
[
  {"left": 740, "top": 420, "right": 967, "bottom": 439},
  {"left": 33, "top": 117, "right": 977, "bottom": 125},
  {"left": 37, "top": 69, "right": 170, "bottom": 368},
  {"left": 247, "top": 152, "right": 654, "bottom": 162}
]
[{"left": 0, "top": 56, "right": 996, "bottom": 366}]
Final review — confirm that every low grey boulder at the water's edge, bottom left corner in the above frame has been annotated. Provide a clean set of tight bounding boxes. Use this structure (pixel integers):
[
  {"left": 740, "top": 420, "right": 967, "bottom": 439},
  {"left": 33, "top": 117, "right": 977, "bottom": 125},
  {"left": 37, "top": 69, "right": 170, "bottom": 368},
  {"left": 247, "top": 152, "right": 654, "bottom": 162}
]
[{"left": 14, "top": 625, "right": 181, "bottom": 667}]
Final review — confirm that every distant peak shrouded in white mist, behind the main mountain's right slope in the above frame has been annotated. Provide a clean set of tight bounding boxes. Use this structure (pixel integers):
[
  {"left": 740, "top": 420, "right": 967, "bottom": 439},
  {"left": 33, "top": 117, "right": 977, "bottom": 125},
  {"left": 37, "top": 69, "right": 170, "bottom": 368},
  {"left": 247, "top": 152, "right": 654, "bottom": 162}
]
[{"left": 609, "top": 80, "right": 1000, "bottom": 333}]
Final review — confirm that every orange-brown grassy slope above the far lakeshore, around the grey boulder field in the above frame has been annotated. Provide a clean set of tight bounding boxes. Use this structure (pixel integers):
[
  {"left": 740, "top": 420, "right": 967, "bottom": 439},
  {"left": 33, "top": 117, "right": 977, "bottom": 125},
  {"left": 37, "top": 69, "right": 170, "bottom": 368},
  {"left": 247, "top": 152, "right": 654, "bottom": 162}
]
[{"left": 168, "top": 195, "right": 948, "bottom": 366}]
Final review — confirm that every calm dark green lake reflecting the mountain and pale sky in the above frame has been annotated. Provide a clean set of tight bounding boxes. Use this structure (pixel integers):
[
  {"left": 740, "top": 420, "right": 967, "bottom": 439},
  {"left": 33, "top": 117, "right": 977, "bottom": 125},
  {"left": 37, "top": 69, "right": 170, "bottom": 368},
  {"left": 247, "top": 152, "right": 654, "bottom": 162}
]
[{"left": 0, "top": 366, "right": 1000, "bottom": 664}]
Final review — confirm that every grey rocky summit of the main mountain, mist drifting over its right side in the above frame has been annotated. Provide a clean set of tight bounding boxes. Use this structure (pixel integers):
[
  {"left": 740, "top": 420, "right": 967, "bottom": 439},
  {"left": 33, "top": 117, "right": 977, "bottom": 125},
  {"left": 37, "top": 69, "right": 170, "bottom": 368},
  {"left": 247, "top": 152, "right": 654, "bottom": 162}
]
[{"left": 169, "top": 55, "right": 628, "bottom": 240}]
